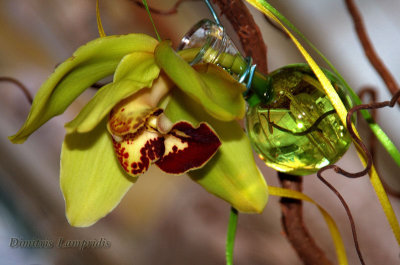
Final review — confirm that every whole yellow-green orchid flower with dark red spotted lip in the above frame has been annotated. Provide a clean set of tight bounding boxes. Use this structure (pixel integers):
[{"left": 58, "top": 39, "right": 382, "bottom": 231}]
[{"left": 10, "top": 34, "right": 268, "bottom": 226}]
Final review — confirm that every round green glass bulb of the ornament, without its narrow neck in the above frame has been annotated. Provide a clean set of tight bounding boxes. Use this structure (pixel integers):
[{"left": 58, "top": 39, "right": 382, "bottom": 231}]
[{"left": 246, "top": 64, "right": 352, "bottom": 175}]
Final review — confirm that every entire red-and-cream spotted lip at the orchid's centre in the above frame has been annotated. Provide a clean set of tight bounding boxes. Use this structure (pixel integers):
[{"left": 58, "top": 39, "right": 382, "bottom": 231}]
[{"left": 108, "top": 103, "right": 221, "bottom": 177}]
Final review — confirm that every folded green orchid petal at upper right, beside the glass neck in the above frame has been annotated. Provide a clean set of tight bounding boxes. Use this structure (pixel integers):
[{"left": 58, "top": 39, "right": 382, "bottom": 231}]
[{"left": 155, "top": 41, "right": 245, "bottom": 121}]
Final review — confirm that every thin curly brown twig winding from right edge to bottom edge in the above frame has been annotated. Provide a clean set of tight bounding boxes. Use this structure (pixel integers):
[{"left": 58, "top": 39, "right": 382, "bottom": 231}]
[{"left": 317, "top": 90, "right": 400, "bottom": 265}]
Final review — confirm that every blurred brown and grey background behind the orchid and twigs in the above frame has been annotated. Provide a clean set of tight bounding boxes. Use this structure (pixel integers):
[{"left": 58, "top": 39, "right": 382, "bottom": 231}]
[{"left": 0, "top": 0, "right": 400, "bottom": 265}]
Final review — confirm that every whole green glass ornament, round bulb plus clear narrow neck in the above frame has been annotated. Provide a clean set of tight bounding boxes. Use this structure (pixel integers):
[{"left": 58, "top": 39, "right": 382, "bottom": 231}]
[{"left": 178, "top": 19, "right": 352, "bottom": 175}]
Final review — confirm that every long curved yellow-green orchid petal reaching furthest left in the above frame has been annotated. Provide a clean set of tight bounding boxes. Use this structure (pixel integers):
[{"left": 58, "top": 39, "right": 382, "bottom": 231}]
[{"left": 9, "top": 34, "right": 157, "bottom": 143}]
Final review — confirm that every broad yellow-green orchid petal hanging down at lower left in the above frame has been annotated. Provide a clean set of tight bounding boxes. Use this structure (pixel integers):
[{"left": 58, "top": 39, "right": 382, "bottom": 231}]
[{"left": 60, "top": 119, "right": 136, "bottom": 227}]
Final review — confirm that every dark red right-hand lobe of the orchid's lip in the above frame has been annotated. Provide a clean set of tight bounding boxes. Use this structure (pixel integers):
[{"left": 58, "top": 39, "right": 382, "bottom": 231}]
[{"left": 156, "top": 122, "right": 221, "bottom": 174}]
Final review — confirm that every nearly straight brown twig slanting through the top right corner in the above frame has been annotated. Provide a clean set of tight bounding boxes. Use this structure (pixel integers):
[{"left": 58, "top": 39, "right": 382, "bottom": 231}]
[{"left": 345, "top": 0, "right": 400, "bottom": 106}]
